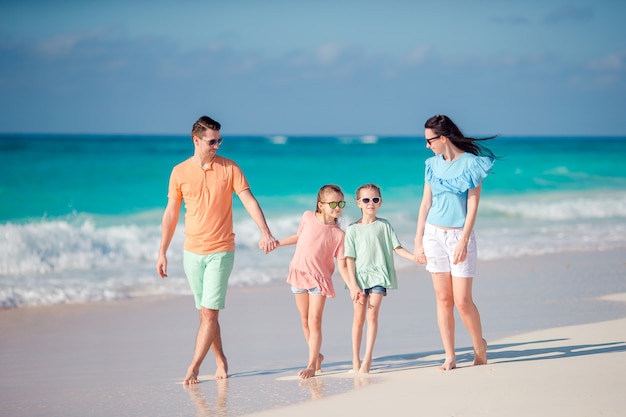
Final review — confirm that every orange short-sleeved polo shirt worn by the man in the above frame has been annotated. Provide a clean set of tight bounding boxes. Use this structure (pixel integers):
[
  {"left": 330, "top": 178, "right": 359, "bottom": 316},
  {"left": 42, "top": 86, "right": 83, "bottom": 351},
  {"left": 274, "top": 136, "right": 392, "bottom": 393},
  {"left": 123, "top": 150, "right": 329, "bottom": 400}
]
[{"left": 167, "top": 155, "right": 250, "bottom": 255}]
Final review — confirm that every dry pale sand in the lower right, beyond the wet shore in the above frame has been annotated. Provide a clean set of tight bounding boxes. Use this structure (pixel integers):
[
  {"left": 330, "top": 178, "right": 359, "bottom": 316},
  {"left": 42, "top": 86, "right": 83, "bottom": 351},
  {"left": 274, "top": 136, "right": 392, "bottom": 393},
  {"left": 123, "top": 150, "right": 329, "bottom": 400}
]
[{"left": 246, "top": 319, "right": 626, "bottom": 417}]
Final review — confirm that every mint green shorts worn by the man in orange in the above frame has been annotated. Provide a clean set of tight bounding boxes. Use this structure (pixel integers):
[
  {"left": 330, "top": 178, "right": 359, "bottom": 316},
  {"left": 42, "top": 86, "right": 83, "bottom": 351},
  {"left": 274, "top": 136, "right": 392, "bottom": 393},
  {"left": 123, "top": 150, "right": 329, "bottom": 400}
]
[{"left": 183, "top": 250, "right": 235, "bottom": 310}]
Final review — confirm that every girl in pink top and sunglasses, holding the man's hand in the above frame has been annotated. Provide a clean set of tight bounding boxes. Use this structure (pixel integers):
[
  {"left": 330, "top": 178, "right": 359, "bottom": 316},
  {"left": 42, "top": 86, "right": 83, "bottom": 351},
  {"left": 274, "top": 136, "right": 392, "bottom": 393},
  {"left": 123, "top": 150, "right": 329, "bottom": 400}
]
[{"left": 279, "top": 184, "right": 360, "bottom": 379}]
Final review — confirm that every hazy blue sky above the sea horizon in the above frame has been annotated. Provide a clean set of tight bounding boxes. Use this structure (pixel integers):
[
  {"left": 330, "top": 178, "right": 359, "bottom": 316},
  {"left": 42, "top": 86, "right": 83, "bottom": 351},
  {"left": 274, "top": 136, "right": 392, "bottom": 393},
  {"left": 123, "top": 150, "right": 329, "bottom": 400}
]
[{"left": 0, "top": 0, "right": 626, "bottom": 135}]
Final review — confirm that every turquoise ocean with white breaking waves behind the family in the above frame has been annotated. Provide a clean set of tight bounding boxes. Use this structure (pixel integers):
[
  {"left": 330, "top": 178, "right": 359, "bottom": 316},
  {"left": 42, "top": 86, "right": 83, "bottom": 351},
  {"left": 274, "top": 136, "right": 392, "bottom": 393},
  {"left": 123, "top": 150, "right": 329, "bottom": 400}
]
[{"left": 0, "top": 134, "right": 626, "bottom": 308}]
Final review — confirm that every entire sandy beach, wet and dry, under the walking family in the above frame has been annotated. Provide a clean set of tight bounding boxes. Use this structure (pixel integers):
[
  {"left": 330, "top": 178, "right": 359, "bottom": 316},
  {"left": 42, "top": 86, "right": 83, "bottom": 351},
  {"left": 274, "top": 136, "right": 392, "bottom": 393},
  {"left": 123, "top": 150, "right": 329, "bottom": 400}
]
[{"left": 0, "top": 251, "right": 626, "bottom": 417}]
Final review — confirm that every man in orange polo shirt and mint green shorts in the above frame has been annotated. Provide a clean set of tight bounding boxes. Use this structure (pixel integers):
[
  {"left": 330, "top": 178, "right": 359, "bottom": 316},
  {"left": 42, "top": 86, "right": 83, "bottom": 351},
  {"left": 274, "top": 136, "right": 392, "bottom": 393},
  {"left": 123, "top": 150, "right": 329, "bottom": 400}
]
[{"left": 156, "top": 116, "right": 278, "bottom": 385}]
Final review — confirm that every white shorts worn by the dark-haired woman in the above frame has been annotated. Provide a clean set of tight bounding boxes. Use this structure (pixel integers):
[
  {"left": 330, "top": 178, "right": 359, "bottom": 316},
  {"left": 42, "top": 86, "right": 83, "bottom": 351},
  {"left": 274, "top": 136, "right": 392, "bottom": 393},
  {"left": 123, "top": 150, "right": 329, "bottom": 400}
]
[{"left": 422, "top": 223, "right": 477, "bottom": 278}]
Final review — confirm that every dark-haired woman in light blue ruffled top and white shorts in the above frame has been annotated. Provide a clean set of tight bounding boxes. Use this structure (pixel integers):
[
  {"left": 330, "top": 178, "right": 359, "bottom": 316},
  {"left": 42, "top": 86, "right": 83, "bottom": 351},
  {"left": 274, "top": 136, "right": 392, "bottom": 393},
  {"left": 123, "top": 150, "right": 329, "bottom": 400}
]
[{"left": 414, "top": 115, "right": 495, "bottom": 371}]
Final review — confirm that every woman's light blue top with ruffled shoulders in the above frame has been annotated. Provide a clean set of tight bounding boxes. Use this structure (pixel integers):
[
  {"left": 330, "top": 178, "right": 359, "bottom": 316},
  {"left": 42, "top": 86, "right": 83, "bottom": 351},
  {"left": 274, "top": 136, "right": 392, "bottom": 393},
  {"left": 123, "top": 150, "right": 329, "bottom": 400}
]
[{"left": 424, "top": 152, "right": 494, "bottom": 227}]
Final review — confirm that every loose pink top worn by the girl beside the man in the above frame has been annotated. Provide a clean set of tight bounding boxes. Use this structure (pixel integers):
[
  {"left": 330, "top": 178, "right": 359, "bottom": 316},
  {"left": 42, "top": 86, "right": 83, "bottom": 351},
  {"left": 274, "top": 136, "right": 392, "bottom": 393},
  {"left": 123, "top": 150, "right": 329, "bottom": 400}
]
[{"left": 287, "top": 211, "right": 345, "bottom": 298}]
